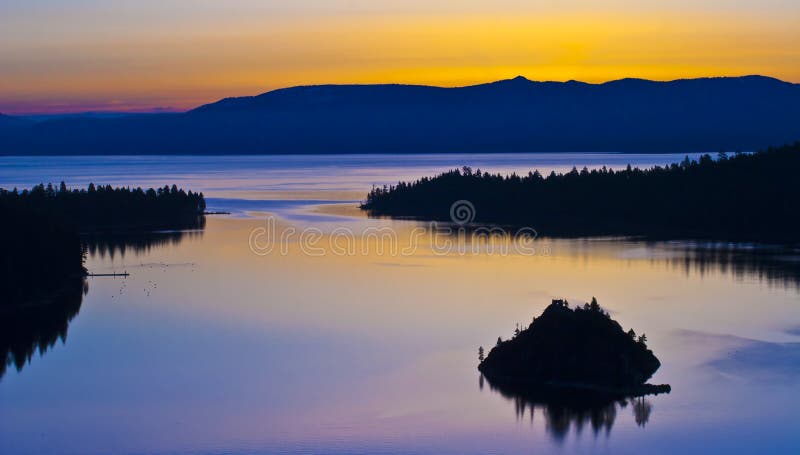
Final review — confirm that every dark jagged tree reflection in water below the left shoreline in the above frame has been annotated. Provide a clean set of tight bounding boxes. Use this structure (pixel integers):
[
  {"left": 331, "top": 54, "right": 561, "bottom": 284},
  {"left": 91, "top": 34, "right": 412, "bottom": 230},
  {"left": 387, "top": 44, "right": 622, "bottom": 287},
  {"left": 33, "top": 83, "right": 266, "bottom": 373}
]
[{"left": 0, "top": 278, "right": 89, "bottom": 379}]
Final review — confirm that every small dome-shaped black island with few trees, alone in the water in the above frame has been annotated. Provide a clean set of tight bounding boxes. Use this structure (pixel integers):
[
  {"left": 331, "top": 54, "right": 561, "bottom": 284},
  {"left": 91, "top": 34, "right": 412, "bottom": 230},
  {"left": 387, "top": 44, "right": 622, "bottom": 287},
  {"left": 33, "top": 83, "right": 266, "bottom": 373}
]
[{"left": 478, "top": 299, "right": 670, "bottom": 395}]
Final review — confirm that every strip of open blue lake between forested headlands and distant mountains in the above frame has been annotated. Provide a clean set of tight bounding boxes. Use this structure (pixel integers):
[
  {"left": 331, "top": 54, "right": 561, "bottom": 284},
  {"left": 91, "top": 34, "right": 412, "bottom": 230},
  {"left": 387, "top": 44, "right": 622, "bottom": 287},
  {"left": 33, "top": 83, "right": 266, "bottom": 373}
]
[{"left": 0, "top": 153, "right": 696, "bottom": 197}]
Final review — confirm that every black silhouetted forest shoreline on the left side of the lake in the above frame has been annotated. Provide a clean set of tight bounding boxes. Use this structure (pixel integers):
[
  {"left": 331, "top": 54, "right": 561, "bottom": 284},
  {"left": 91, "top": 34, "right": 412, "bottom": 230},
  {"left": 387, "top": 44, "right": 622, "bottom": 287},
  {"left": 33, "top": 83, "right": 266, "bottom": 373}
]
[{"left": 0, "top": 182, "right": 205, "bottom": 306}]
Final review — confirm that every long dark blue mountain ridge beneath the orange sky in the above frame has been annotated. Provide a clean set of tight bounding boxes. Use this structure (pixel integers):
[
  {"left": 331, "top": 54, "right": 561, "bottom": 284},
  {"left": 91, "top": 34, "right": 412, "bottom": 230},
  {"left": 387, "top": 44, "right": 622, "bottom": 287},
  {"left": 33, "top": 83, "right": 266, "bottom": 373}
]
[{"left": 0, "top": 76, "right": 800, "bottom": 154}]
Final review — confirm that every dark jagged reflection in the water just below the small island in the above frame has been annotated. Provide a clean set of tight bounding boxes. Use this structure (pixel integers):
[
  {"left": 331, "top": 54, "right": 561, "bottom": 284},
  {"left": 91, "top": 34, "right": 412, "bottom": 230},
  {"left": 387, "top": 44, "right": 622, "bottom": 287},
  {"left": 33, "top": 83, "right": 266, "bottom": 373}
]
[{"left": 480, "top": 376, "right": 664, "bottom": 444}]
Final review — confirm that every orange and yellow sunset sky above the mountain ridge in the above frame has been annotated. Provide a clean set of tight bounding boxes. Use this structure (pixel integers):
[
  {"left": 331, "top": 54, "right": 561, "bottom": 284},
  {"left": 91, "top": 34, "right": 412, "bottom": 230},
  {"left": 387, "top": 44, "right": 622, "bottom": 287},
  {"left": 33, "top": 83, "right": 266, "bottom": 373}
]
[{"left": 0, "top": 0, "right": 800, "bottom": 114}]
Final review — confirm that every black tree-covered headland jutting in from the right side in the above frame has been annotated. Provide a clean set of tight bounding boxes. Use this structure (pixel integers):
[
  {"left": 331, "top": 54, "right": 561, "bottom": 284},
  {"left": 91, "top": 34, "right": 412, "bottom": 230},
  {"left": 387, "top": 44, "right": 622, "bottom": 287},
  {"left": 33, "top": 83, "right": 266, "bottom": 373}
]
[{"left": 362, "top": 143, "right": 800, "bottom": 243}]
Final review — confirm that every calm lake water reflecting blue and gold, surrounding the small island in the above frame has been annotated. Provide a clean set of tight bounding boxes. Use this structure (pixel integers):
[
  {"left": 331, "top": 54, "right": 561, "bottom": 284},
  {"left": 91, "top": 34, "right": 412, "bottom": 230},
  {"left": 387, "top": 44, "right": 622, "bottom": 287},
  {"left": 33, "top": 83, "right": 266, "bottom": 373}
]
[{"left": 0, "top": 154, "right": 800, "bottom": 454}]
